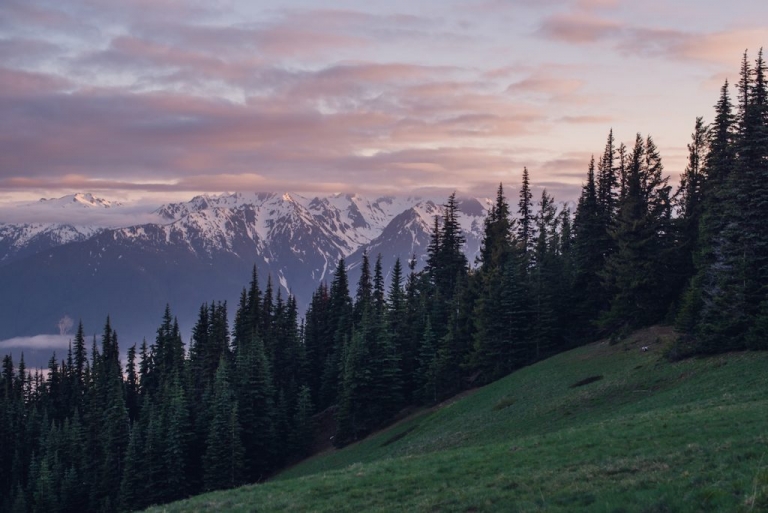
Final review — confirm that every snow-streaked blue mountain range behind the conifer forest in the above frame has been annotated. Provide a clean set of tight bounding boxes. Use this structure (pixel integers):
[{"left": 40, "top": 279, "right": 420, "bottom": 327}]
[{"left": 0, "top": 193, "right": 489, "bottom": 358}]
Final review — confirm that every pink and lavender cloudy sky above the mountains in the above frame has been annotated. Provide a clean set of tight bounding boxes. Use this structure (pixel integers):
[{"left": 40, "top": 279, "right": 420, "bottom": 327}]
[{"left": 0, "top": 0, "right": 768, "bottom": 203}]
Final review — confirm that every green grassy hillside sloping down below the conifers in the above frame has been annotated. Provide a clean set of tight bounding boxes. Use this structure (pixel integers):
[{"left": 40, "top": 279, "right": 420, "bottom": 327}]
[{"left": 146, "top": 328, "right": 768, "bottom": 512}]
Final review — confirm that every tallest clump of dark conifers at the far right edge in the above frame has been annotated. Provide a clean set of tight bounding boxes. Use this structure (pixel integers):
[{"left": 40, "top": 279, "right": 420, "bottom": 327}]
[{"left": 677, "top": 51, "right": 768, "bottom": 353}]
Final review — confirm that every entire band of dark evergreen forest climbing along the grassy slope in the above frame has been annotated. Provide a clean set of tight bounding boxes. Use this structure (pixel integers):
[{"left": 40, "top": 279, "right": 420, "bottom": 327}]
[{"left": 0, "top": 52, "right": 768, "bottom": 512}]
